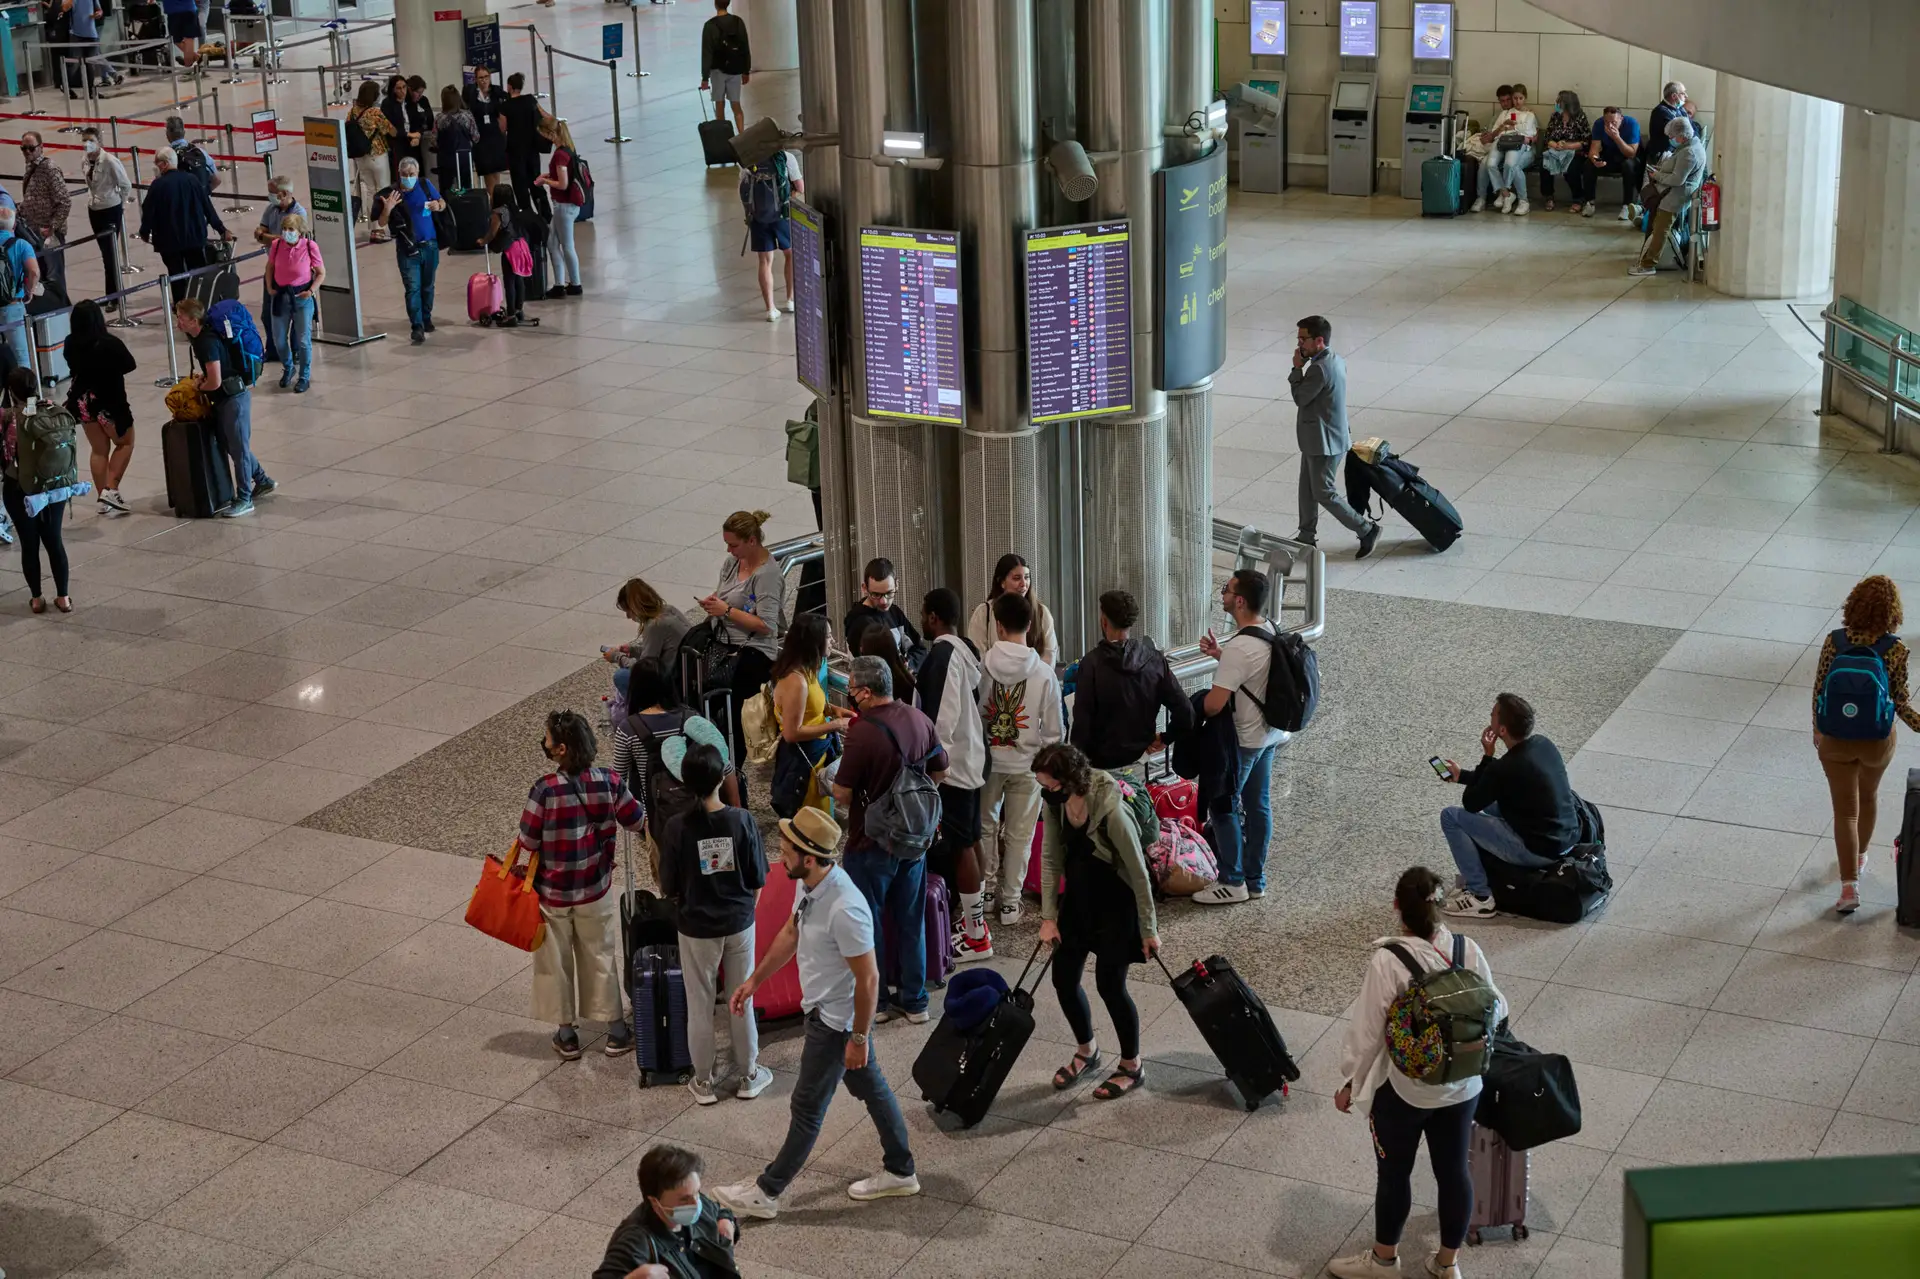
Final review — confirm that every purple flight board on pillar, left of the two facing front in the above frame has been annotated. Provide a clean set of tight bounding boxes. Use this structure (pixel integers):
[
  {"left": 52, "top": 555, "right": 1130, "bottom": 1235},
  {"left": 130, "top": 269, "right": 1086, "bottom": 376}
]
[{"left": 860, "top": 227, "right": 966, "bottom": 426}]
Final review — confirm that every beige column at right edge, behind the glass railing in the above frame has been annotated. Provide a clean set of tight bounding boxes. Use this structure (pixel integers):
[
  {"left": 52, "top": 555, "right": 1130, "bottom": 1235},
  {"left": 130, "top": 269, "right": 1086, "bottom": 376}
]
[{"left": 1834, "top": 108, "right": 1920, "bottom": 332}]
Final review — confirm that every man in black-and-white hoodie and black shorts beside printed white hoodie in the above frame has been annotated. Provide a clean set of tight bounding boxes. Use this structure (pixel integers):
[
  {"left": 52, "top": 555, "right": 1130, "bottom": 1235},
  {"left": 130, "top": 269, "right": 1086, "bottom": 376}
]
[{"left": 916, "top": 586, "right": 993, "bottom": 964}]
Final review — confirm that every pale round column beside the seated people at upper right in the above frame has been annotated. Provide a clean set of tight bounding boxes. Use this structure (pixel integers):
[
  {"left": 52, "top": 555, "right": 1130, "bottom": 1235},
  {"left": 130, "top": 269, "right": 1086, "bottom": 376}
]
[{"left": 1707, "top": 75, "right": 1841, "bottom": 298}]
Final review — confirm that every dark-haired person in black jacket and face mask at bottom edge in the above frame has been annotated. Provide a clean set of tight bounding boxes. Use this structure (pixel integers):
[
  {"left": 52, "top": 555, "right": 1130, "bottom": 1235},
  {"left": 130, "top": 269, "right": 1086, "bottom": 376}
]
[{"left": 593, "top": 1143, "right": 739, "bottom": 1279}]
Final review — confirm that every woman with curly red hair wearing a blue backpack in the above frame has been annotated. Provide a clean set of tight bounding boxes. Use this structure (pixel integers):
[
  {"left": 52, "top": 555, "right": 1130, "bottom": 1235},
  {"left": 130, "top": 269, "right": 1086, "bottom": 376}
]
[{"left": 1812, "top": 572, "right": 1920, "bottom": 914}]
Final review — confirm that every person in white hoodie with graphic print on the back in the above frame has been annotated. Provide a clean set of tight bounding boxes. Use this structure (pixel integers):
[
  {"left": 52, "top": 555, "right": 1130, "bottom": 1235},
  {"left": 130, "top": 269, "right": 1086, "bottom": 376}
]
[{"left": 979, "top": 591, "right": 1066, "bottom": 924}]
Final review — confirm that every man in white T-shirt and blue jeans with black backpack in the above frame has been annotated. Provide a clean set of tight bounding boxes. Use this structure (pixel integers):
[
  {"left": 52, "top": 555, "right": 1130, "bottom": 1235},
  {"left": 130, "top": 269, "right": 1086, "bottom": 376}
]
[{"left": 1194, "top": 568, "right": 1286, "bottom": 906}]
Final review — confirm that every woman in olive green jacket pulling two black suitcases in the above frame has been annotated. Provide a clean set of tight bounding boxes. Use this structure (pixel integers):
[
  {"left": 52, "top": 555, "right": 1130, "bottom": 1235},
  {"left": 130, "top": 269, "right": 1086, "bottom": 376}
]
[{"left": 1033, "top": 743, "right": 1160, "bottom": 1100}]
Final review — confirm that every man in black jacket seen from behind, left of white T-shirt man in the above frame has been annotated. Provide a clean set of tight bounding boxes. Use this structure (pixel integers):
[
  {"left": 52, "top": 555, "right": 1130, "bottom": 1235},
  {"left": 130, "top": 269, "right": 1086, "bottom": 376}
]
[{"left": 1073, "top": 591, "right": 1194, "bottom": 768}]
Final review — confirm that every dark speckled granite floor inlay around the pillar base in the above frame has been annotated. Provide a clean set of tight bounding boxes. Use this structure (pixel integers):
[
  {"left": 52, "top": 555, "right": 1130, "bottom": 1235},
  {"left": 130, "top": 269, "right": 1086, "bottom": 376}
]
[{"left": 301, "top": 591, "right": 1680, "bottom": 1016}]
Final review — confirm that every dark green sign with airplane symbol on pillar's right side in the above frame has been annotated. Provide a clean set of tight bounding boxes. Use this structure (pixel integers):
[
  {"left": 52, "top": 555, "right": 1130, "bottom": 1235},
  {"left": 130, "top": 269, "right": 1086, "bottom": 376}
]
[{"left": 1154, "top": 146, "right": 1227, "bottom": 390}]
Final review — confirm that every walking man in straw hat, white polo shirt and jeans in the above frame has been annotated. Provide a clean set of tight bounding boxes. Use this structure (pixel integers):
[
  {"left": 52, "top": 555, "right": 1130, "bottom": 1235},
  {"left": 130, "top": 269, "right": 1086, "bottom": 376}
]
[{"left": 712, "top": 808, "right": 920, "bottom": 1219}]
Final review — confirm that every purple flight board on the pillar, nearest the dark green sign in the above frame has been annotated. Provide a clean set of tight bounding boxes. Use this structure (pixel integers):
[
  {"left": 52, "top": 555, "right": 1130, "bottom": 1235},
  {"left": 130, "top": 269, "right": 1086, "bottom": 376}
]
[{"left": 1027, "top": 223, "right": 1133, "bottom": 422}]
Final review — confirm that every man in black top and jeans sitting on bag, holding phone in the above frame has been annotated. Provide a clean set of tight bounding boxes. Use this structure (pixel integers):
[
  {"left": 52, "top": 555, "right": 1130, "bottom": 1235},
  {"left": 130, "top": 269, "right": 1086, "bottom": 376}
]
[{"left": 1440, "top": 693, "right": 1580, "bottom": 916}]
